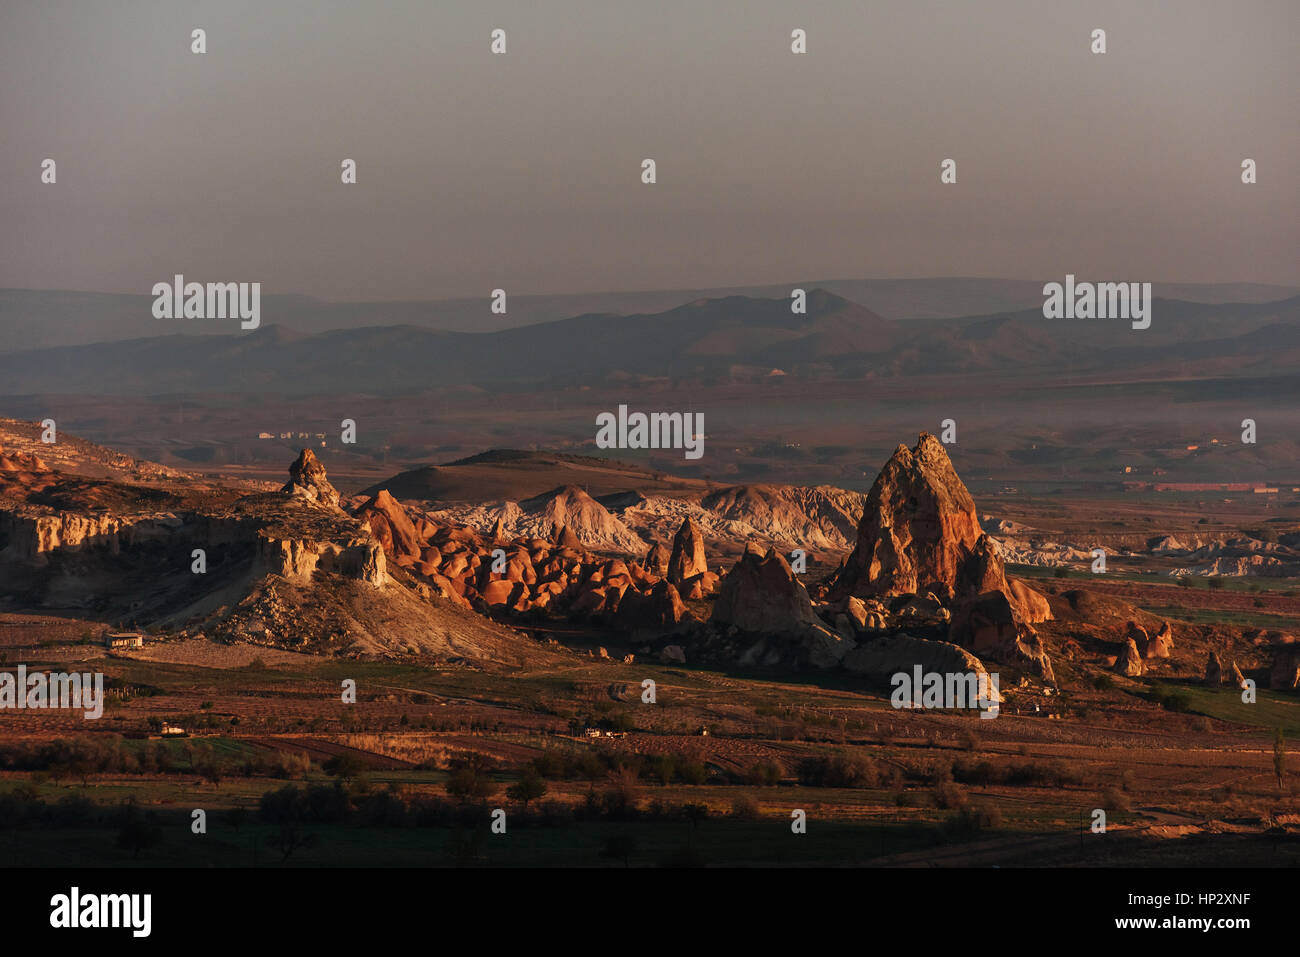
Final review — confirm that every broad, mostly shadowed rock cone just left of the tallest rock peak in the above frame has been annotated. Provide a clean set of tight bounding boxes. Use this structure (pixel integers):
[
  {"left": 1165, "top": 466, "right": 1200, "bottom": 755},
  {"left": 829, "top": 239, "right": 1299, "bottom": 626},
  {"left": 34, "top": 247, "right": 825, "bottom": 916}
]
[{"left": 712, "top": 542, "right": 822, "bottom": 635}]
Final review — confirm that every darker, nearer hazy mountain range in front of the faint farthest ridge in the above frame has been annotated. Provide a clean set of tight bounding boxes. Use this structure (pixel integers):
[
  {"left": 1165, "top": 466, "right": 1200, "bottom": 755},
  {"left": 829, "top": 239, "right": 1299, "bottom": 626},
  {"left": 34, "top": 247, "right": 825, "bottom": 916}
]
[{"left": 0, "top": 289, "right": 1300, "bottom": 395}]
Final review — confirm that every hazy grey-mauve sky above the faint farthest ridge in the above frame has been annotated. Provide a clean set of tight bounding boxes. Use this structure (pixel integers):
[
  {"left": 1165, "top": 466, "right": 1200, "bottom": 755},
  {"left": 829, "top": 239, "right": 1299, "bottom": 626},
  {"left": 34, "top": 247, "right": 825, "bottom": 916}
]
[{"left": 0, "top": 0, "right": 1300, "bottom": 299}]
